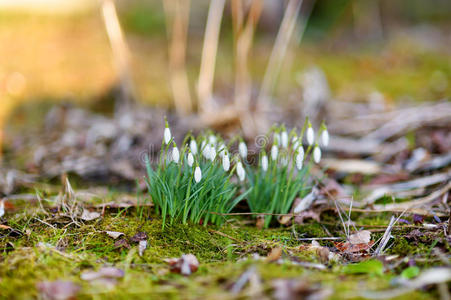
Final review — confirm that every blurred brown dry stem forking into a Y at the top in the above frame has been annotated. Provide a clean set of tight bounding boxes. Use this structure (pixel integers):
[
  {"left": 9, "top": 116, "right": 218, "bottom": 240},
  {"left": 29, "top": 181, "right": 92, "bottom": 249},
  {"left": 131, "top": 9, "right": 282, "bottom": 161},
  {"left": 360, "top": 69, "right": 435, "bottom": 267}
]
[{"left": 232, "top": 0, "right": 262, "bottom": 136}]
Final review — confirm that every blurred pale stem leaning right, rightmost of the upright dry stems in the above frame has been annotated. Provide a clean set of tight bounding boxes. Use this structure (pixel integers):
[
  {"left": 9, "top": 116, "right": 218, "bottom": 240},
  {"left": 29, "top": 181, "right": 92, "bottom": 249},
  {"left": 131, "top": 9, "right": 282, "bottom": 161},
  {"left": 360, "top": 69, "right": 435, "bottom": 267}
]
[{"left": 258, "top": 0, "right": 302, "bottom": 103}]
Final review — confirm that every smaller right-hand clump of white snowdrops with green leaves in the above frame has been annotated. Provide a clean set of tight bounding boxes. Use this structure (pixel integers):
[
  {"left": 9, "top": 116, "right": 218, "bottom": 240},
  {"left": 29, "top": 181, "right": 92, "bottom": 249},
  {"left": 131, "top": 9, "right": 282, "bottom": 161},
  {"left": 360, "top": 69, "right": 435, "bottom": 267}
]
[{"left": 247, "top": 119, "right": 329, "bottom": 228}]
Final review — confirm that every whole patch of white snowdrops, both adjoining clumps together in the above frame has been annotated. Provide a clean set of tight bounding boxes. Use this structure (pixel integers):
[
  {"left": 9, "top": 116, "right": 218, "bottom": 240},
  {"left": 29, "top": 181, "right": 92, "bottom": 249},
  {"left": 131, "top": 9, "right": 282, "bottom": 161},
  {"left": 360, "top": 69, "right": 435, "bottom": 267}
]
[{"left": 146, "top": 120, "right": 329, "bottom": 228}]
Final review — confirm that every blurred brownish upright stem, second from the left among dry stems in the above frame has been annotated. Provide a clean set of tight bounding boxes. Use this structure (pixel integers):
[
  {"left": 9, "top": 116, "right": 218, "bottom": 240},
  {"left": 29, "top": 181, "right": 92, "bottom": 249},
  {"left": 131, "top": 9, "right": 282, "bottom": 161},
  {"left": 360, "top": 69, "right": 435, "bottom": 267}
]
[{"left": 163, "top": 0, "right": 193, "bottom": 115}]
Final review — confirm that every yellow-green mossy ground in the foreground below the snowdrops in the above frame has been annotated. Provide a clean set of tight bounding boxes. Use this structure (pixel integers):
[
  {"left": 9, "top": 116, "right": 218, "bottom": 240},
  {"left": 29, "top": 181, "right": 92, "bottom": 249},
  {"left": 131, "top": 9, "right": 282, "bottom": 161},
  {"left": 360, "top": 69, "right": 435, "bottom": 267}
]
[{"left": 0, "top": 191, "right": 444, "bottom": 299}]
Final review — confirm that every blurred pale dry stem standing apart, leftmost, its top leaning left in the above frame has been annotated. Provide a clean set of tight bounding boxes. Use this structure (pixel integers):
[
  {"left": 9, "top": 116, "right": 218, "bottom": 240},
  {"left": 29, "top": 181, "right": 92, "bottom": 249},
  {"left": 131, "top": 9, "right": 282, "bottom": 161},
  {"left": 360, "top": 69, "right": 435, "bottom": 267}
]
[{"left": 102, "top": 0, "right": 135, "bottom": 106}]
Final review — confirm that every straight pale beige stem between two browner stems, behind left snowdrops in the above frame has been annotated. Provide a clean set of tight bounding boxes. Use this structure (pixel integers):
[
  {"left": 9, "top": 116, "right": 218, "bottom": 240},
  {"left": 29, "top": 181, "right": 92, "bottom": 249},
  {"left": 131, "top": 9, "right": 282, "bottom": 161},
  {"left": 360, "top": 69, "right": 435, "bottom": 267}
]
[{"left": 197, "top": 0, "right": 225, "bottom": 112}]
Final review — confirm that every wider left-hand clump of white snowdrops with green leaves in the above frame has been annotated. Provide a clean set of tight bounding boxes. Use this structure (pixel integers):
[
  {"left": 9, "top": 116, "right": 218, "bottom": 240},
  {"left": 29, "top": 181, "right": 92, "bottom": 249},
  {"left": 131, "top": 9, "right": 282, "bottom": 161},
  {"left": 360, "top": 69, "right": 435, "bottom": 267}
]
[{"left": 146, "top": 121, "right": 248, "bottom": 228}]
